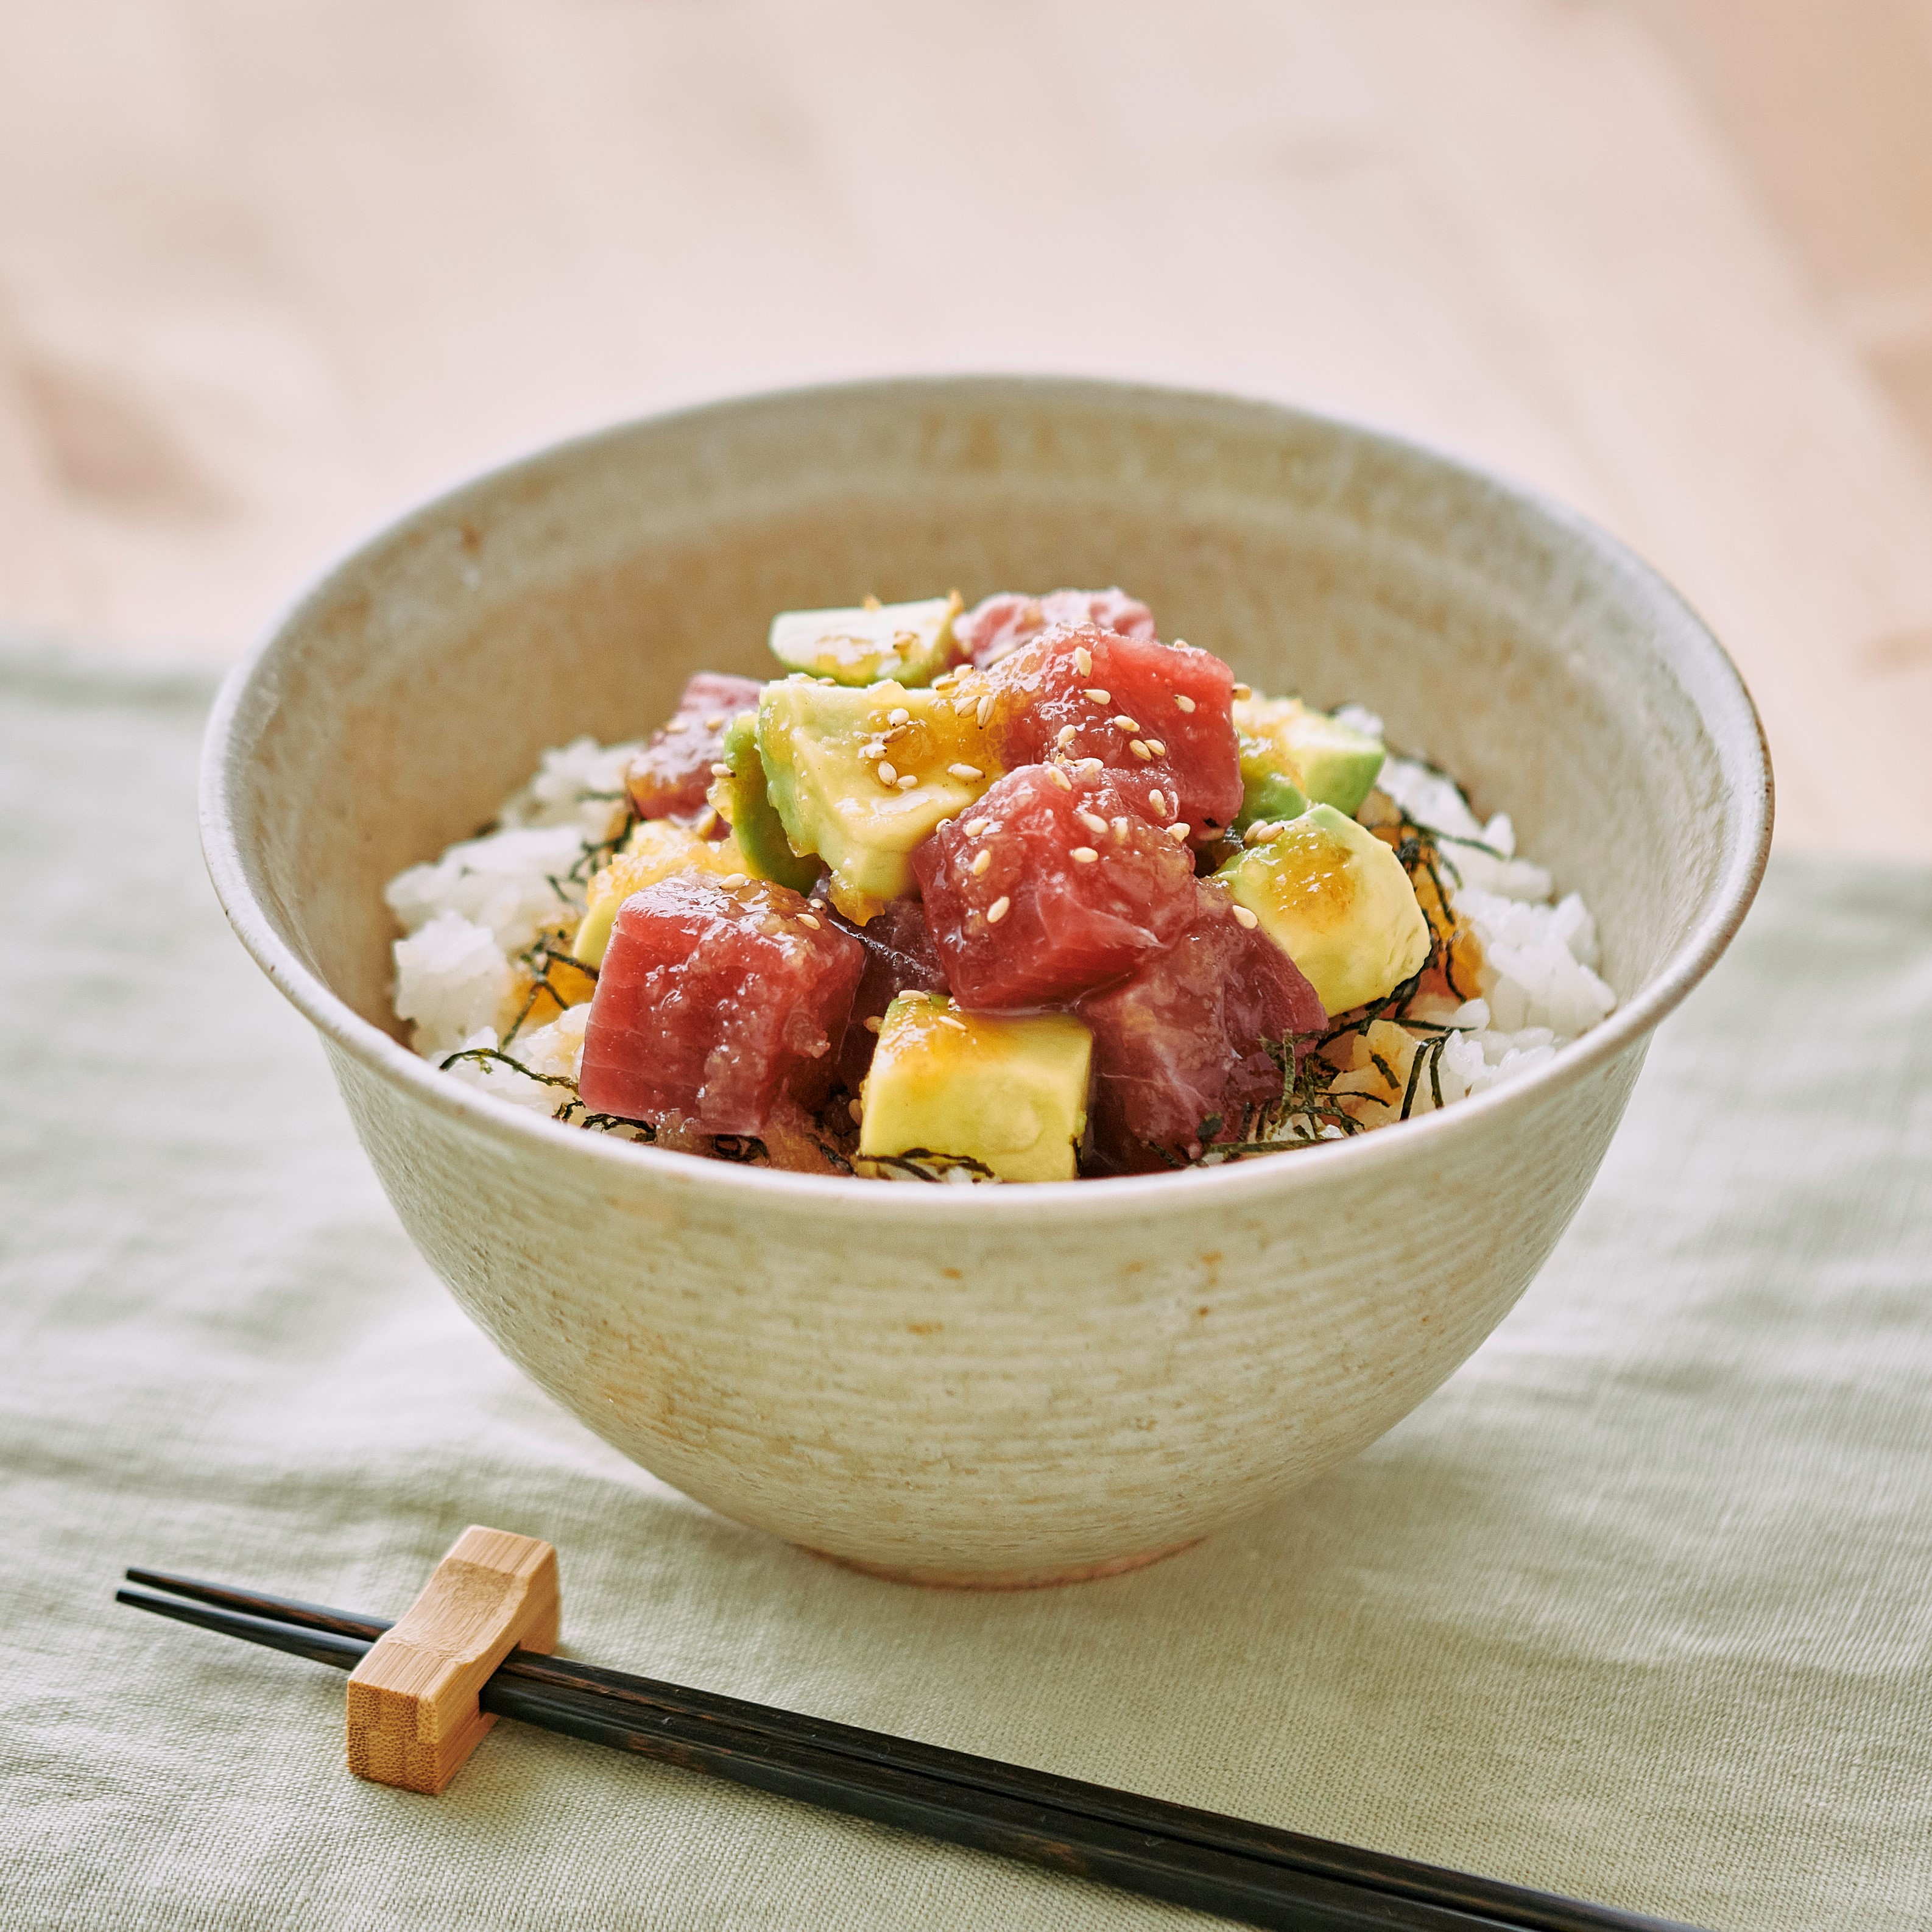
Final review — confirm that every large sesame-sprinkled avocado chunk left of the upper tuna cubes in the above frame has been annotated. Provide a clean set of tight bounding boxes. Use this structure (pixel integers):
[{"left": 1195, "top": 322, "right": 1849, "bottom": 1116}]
[{"left": 757, "top": 676, "right": 1003, "bottom": 925}]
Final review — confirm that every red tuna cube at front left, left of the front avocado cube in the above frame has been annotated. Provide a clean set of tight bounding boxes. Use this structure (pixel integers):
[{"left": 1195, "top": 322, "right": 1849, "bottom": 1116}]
[{"left": 577, "top": 872, "right": 866, "bottom": 1134}]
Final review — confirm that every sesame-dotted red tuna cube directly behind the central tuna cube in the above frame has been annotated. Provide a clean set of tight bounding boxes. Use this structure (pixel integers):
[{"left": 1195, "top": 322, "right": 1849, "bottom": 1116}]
[{"left": 981, "top": 626, "right": 1240, "bottom": 844}]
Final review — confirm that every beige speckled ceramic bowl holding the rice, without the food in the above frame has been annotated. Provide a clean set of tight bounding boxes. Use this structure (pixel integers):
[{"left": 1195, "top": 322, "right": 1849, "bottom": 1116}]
[{"left": 203, "top": 379, "right": 1770, "bottom": 1584}]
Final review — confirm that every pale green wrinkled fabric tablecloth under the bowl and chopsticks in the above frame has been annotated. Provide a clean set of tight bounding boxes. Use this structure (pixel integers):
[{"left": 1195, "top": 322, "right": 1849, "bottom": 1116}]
[{"left": 0, "top": 653, "right": 1932, "bottom": 1932}]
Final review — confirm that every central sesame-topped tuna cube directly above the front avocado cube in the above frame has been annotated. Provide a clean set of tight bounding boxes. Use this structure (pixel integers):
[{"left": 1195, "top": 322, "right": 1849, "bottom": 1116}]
[{"left": 912, "top": 765, "right": 1194, "bottom": 1009}]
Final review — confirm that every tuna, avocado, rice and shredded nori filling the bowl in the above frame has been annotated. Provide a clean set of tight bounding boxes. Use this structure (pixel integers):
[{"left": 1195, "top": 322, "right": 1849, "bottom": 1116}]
[{"left": 386, "top": 589, "right": 1615, "bottom": 1184}]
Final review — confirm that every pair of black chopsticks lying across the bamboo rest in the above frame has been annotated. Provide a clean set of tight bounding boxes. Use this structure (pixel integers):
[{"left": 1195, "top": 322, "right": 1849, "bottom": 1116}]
[{"left": 120, "top": 1569, "right": 1708, "bottom": 1932}]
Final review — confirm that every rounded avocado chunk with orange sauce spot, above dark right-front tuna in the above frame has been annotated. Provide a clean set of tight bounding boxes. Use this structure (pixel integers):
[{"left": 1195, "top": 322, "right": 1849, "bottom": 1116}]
[{"left": 1215, "top": 806, "right": 1430, "bottom": 1018}]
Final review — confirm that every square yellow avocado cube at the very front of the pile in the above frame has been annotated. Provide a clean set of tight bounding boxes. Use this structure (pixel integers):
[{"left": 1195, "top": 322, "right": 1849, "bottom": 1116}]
[{"left": 858, "top": 993, "right": 1093, "bottom": 1180}]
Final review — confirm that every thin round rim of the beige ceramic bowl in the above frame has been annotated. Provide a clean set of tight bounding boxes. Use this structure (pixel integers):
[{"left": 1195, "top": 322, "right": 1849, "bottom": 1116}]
[{"left": 199, "top": 373, "right": 1774, "bottom": 1225}]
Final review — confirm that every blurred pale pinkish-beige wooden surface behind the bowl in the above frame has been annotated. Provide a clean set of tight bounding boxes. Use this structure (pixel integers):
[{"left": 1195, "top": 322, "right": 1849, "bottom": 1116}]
[{"left": 0, "top": 0, "right": 1932, "bottom": 852}]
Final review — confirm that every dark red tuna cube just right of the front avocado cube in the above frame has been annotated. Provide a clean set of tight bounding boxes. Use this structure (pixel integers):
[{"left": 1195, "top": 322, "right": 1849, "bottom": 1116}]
[{"left": 1076, "top": 881, "right": 1327, "bottom": 1172}]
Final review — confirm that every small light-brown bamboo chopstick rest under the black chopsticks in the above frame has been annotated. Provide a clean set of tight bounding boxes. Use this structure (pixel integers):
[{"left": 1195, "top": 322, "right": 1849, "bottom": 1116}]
[{"left": 350, "top": 1525, "right": 562, "bottom": 1797}]
